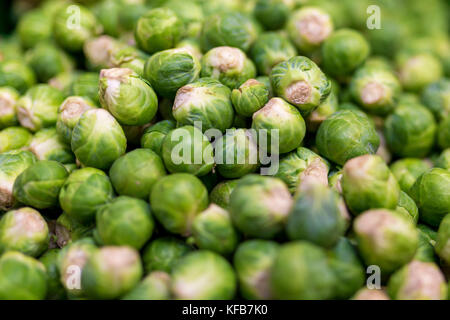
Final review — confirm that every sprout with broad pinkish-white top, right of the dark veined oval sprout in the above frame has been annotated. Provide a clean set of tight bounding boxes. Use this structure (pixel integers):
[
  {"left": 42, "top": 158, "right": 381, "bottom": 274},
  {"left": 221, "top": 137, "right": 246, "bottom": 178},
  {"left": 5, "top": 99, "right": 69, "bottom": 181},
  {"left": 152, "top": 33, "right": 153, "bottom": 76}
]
[{"left": 201, "top": 46, "right": 256, "bottom": 89}]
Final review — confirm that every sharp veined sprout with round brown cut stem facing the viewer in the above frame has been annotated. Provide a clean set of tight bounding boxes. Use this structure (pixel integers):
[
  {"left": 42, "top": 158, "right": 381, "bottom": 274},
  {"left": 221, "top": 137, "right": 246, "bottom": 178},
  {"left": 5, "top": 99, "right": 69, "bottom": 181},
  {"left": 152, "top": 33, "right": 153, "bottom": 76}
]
[{"left": 270, "top": 56, "right": 331, "bottom": 116}]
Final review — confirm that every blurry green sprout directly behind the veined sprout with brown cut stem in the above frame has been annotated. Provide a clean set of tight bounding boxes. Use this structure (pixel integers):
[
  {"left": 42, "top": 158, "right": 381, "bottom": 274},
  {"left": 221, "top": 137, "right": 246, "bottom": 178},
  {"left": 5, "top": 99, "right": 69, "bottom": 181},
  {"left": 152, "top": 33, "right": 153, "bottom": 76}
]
[{"left": 250, "top": 32, "right": 297, "bottom": 75}]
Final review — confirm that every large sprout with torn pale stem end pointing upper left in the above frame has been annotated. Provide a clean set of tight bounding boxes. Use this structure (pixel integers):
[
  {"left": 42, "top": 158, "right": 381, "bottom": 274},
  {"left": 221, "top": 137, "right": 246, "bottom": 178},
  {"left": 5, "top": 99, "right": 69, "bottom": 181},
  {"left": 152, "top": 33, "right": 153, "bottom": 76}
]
[{"left": 99, "top": 68, "right": 158, "bottom": 125}]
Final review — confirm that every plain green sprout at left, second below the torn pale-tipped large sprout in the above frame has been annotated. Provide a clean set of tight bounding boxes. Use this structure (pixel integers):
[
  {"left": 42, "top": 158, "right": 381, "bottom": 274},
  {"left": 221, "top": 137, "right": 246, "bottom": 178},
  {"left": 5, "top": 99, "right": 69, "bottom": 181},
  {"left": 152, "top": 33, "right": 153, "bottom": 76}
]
[{"left": 59, "top": 168, "right": 114, "bottom": 224}]
